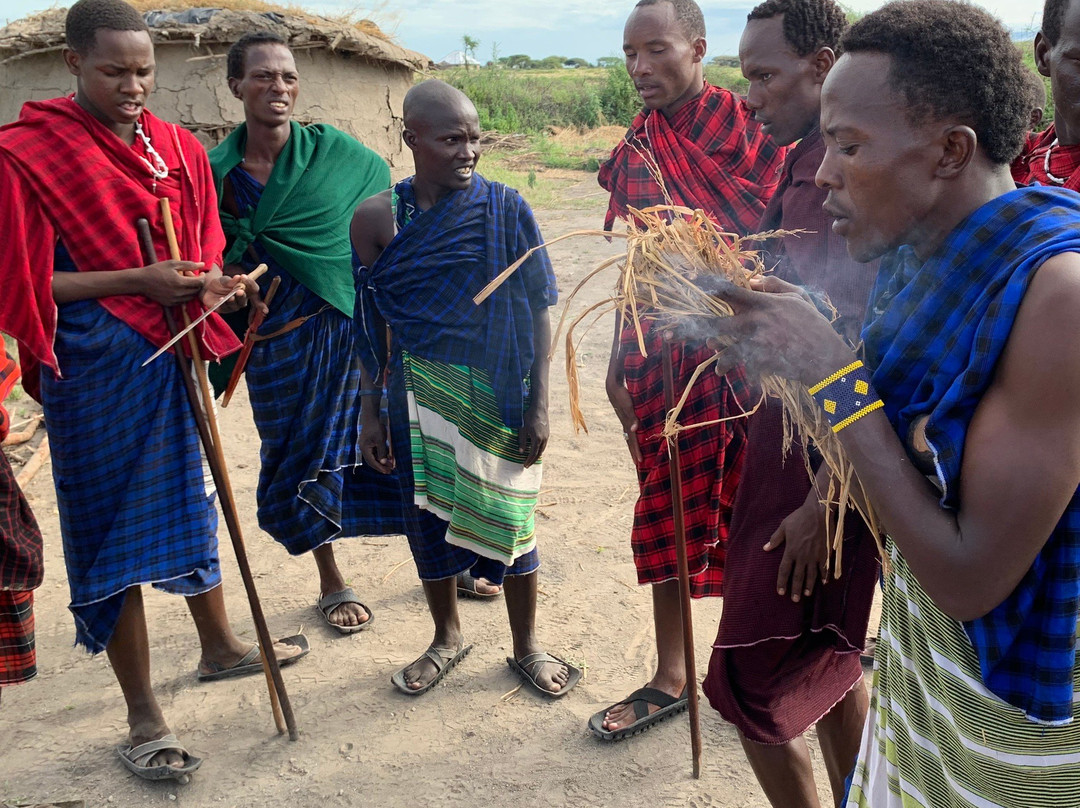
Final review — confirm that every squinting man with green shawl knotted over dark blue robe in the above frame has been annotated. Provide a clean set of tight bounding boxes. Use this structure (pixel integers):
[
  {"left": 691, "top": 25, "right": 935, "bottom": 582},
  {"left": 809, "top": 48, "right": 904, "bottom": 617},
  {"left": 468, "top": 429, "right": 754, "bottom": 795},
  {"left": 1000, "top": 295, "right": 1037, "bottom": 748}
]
[{"left": 210, "top": 32, "right": 402, "bottom": 634}]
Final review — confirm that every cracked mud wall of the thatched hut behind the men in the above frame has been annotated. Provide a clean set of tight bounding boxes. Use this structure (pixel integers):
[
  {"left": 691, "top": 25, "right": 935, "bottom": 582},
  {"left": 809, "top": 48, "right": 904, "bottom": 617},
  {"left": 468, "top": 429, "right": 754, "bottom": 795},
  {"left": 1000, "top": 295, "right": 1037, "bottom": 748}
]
[{"left": 0, "top": 42, "right": 413, "bottom": 168}]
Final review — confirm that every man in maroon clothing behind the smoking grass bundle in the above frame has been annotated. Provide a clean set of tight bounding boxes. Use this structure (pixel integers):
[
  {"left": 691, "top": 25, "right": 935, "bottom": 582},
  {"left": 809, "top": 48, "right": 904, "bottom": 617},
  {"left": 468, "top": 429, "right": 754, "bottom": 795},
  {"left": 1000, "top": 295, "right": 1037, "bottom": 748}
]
[{"left": 704, "top": 0, "right": 879, "bottom": 808}]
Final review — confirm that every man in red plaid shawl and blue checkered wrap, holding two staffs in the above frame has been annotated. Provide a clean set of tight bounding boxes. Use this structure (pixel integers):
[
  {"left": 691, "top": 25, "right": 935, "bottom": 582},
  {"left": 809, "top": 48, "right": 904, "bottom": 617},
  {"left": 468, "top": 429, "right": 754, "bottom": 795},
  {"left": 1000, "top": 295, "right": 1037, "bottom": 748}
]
[{"left": 0, "top": 0, "right": 302, "bottom": 782}]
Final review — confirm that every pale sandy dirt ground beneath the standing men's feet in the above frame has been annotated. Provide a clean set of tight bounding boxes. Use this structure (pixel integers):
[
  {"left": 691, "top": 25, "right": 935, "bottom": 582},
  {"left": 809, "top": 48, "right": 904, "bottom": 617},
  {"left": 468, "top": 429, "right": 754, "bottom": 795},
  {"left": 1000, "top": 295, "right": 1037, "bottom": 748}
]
[{"left": 0, "top": 181, "right": 872, "bottom": 808}]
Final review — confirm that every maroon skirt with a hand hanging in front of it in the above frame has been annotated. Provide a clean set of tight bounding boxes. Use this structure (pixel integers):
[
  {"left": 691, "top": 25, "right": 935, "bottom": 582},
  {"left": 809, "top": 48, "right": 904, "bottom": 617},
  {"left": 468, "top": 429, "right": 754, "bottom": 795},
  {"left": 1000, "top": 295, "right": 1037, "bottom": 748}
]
[{"left": 704, "top": 401, "right": 879, "bottom": 744}]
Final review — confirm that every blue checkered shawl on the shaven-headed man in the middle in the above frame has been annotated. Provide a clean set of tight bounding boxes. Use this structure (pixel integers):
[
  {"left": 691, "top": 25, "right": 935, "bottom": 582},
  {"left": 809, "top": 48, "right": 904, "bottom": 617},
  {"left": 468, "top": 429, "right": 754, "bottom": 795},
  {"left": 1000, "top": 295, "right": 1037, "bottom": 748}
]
[{"left": 356, "top": 174, "right": 558, "bottom": 429}]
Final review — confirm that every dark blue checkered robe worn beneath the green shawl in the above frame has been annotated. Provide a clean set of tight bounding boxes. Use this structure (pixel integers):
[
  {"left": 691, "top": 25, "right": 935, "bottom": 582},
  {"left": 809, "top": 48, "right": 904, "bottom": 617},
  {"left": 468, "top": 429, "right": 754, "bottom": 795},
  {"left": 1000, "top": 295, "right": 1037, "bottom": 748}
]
[{"left": 229, "top": 166, "right": 405, "bottom": 555}]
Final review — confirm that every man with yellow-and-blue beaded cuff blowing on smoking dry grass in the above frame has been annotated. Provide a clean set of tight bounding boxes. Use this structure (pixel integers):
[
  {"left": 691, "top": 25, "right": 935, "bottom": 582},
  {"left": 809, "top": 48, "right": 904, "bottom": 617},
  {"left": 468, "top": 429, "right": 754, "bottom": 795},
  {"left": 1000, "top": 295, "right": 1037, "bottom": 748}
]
[{"left": 693, "top": 0, "right": 1080, "bottom": 808}]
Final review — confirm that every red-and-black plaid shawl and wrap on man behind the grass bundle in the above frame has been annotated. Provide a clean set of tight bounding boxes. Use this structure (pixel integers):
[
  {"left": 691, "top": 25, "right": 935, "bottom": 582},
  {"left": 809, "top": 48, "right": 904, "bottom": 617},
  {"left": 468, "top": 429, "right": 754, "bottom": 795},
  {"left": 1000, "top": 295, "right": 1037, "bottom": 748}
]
[{"left": 599, "top": 84, "right": 785, "bottom": 597}]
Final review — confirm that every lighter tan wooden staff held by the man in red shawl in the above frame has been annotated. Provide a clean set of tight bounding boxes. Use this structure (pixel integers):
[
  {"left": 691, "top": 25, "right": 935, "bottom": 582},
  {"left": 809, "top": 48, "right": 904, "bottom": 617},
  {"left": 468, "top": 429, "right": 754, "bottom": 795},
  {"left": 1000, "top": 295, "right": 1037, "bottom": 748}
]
[{"left": 149, "top": 199, "right": 300, "bottom": 741}]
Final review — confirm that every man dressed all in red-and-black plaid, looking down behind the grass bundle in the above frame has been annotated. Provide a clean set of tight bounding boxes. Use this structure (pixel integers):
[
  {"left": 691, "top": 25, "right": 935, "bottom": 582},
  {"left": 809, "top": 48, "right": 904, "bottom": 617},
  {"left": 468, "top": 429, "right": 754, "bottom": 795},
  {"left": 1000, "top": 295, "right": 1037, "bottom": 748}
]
[{"left": 589, "top": 0, "right": 784, "bottom": 741}]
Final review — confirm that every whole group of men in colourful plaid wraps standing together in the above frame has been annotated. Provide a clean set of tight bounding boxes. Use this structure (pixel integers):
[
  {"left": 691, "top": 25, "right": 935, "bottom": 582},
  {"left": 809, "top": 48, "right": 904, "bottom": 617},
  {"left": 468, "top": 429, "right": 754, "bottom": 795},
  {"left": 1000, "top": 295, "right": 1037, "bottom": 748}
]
[{"left": 0, "top": 0, "right": 1080, "bottom": 807}]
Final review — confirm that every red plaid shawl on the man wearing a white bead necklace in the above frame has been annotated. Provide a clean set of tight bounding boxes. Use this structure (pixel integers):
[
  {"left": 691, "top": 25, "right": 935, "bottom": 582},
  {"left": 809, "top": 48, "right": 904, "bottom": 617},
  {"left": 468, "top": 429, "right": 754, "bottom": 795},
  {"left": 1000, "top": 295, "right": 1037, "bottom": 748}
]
[{"left": 0, "top": 97, "right": 240, "bottom": 376}]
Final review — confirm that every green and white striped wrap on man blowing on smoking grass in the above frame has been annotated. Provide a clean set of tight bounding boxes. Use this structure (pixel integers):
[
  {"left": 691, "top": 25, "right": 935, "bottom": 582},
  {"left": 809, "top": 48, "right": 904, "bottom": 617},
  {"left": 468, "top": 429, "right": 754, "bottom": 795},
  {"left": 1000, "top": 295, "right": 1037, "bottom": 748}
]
[{"left": 848, "top": 540, "right": 1080, "bottom": 808}]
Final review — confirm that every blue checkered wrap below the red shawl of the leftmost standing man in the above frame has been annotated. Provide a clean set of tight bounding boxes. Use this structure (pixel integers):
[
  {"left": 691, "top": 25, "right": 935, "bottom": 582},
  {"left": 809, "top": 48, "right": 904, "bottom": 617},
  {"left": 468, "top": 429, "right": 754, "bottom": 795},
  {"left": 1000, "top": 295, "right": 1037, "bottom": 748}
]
[{"left": 41, "top": 246, "right": 221, "bottom": 654}]
